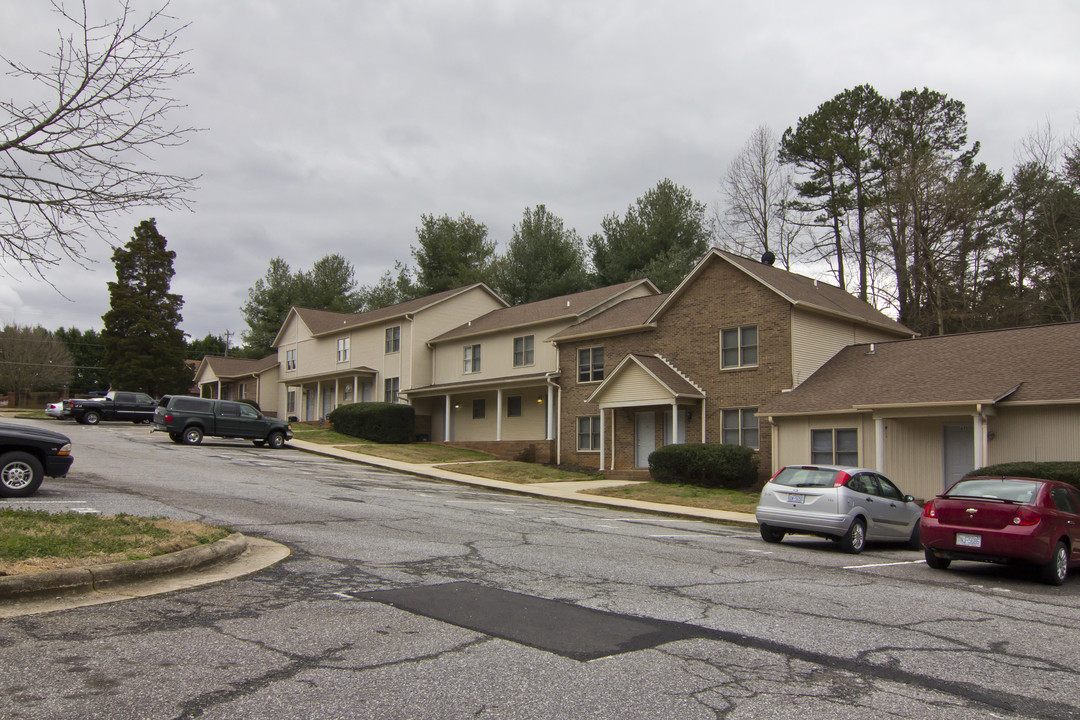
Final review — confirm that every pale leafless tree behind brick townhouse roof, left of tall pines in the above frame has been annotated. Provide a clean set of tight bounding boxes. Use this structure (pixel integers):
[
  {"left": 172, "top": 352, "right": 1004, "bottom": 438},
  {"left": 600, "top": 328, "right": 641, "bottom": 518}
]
[{"left": 713, "top": 125, "right": 804, "bottom": 270}]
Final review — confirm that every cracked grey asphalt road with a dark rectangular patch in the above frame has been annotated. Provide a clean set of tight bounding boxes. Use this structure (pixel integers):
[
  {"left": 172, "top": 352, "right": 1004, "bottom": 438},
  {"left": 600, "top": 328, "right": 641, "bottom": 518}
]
[{"left": 0, "top": 421, "right": 1080, "bottom": 720}]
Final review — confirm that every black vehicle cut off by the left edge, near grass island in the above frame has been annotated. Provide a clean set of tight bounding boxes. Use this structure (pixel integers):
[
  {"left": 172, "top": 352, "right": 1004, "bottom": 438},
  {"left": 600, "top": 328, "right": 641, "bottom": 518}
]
[{"left": 0, "top": 423, "right": 72, "bottom": 498}]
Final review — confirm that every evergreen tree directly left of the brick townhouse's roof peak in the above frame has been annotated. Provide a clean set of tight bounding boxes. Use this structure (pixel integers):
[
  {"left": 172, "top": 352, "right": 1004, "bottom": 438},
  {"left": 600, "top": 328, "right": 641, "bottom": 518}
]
[{"left": 589, "top": 178, "right": 708, "bottom": 290}]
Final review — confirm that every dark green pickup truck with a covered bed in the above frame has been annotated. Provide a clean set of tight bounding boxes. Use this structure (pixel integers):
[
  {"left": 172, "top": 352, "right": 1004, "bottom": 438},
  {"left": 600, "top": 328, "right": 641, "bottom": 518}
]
[{"left": 153, "top": 395, "right": 293, "bottom": 449}]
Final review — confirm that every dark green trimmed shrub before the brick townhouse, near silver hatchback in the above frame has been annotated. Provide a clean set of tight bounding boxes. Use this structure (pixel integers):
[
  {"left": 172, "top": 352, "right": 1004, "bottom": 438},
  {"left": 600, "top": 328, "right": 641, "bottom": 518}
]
[{"left": 649, "top": 443, "right": 758, "bottom": 490}]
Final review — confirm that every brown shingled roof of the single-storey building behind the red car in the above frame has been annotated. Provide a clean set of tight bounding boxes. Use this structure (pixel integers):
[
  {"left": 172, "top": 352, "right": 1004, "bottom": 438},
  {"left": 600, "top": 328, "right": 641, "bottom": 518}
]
[{"left": 758, "top": 323, "right": 1080, "bottom": 416}]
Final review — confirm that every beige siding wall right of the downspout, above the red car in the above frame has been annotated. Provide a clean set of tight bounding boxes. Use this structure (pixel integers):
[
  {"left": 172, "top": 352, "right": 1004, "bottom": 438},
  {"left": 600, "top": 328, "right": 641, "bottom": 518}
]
[{"left": 987, "top": 405, "right": 1080, "bottom": 464}]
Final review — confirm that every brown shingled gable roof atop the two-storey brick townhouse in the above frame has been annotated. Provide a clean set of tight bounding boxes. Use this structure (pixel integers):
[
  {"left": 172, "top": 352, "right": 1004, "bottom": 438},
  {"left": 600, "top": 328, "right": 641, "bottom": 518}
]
[{"left": 647, "top": 247, "right": 915, "bottom": 337}]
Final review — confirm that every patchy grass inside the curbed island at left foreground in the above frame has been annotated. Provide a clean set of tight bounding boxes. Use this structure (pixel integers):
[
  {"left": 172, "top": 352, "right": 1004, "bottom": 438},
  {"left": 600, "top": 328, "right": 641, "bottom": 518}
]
[{"left": 0, "top": 508, "right": 231, "bottom": 575}]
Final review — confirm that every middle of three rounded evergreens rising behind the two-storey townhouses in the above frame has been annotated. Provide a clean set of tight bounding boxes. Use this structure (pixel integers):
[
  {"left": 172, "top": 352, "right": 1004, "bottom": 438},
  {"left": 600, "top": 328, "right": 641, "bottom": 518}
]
[{"left": 496, "top": 205, "right": 590, "bottom": 304}]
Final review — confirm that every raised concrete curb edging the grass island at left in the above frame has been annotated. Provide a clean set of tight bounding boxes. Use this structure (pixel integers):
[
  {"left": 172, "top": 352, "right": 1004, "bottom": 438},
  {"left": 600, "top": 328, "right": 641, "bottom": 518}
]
[{"left": 0, "top": 532, "right": 247, "bottom": 600}]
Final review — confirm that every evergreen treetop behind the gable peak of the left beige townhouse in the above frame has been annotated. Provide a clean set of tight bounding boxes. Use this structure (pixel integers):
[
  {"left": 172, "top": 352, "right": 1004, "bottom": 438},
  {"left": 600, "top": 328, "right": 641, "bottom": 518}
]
[{"left": 413, "top": 213, "right": 495, "bottom": 296}]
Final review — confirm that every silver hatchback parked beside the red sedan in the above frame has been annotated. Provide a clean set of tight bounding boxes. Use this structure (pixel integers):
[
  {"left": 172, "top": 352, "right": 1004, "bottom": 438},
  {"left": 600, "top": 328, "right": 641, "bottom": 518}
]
[{"left": 755, "top": 465, "right": 922, "bottom": 553}]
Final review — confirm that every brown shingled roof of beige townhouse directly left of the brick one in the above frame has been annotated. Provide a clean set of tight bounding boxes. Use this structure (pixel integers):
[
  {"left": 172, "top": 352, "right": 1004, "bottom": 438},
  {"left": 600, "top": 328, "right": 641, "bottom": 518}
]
[{"left": 429, "top": 280, "right": 660, "bottom": 343}]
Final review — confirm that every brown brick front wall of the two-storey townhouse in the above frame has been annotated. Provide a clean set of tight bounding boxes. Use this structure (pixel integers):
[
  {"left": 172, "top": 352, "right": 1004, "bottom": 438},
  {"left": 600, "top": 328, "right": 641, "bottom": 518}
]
[{"left": 558, "top": 257, "right": 792, "bottom": 477}]
